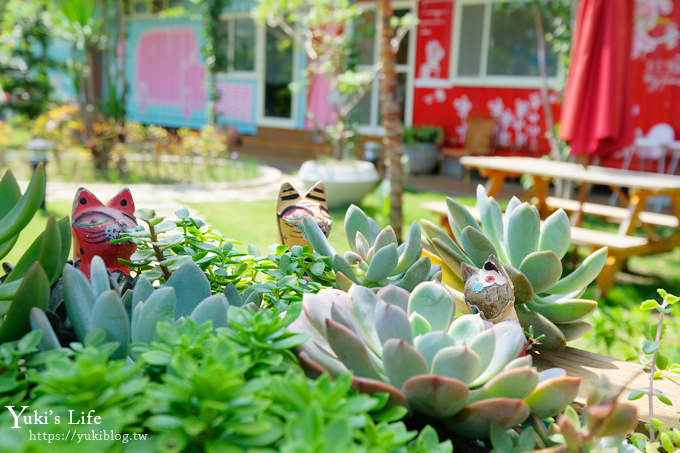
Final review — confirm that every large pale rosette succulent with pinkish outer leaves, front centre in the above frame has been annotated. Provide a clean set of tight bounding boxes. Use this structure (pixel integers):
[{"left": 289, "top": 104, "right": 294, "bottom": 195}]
[{"left": 290, "top": 282, "right": 580, "bottom": 437}]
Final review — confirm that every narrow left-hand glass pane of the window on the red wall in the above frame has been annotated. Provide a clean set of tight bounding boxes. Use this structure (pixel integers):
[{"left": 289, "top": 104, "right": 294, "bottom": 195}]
[{"left": 458, "top": 5, "right": 485, "bottom": 76}]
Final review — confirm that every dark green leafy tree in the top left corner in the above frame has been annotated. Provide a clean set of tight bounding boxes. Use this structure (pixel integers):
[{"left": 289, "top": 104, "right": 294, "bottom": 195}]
[{"left": 0, "top": 0, "right": 55, "bottom": 118}]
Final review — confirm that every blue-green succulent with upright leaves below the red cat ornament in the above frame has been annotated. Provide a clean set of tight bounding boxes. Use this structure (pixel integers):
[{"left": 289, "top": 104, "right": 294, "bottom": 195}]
[{"left": 30, "top": 257, "right": 232, "bottom": 358}]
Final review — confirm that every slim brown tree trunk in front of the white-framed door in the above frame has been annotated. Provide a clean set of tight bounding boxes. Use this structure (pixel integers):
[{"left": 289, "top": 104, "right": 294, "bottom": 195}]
[{"left": 379, "top": 0, "right": 404, "bottom": 239}]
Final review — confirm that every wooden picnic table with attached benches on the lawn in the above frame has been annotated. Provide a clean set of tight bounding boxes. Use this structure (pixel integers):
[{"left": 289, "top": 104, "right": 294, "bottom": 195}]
[{"left": 426, "top": 156, "right": 680, "bottom": 292}]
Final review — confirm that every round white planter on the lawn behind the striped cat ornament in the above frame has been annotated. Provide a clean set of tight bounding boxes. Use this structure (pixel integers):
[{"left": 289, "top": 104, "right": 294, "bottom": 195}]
[{"left": 298, "top": 160, "right": 379, "bottom": 209}]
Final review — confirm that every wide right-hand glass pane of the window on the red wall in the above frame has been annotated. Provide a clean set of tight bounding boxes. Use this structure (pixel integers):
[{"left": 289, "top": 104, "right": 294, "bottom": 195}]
[{"left": 487, "top": 5, "right": 557, "bottom": 77}]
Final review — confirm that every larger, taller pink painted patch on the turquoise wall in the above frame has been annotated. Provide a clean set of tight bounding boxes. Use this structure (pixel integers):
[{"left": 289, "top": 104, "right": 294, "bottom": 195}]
[{"left": 134, "top": 26, "right": 206, "bottom": 118}]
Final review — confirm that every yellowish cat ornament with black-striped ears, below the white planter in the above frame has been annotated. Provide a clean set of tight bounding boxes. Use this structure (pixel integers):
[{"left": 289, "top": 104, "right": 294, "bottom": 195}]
[{"left": 276, "top": 182, "right": 333, "bottom": 246}]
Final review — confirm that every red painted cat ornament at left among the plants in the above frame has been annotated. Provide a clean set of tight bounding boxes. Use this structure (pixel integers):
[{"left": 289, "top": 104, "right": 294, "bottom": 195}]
[{"left": 71, "top": 188, "right": 137, "bottom": 278}]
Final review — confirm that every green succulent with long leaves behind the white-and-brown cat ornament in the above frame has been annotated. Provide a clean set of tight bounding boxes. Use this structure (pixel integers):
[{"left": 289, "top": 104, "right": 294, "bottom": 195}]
[{"left": 421, "top": 185, "right": 607, "bottom": 349}]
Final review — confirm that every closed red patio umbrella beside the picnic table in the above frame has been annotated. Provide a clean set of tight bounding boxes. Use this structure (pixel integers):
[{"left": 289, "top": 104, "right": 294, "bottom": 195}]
[{"left": 560, "top": 0, "right": 635, "bottom": 161}]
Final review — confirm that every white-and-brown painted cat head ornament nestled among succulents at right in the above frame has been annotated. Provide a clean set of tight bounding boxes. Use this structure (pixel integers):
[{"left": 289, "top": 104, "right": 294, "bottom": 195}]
[{"left": 462, "top": 255, "right": 519, "bottom": 323}]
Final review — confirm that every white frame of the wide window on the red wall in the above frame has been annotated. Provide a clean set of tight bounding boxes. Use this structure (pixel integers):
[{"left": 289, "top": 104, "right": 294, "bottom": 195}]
[{"left": 449, "top": 0, "right": 565, "bottom": 88}]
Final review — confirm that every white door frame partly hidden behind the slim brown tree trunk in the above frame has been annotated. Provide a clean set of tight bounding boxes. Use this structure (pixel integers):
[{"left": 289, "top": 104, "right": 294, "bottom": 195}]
[{"left": 357, "top": 1, "right": 418, "bottom": 135}]
